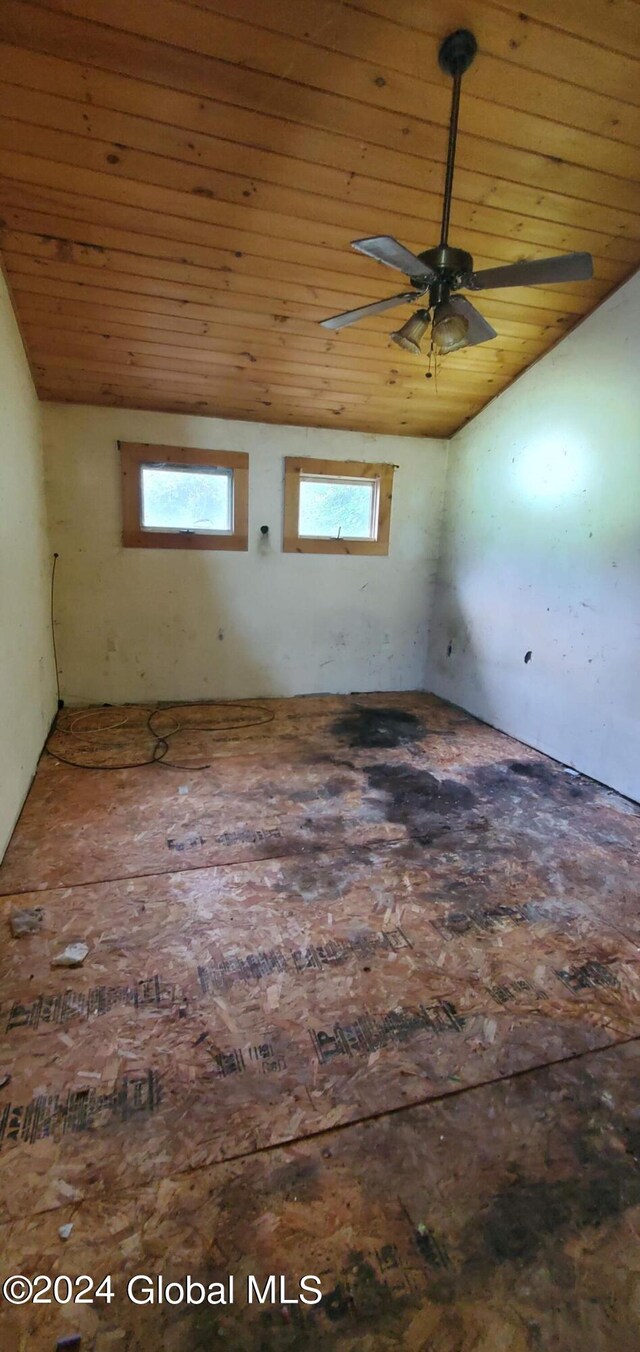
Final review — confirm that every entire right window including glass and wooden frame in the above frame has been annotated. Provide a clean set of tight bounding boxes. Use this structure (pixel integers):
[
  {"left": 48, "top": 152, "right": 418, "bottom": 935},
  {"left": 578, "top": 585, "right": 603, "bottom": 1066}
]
[{"left": 284, "top": 457, "right": 394, "bottom": 554}]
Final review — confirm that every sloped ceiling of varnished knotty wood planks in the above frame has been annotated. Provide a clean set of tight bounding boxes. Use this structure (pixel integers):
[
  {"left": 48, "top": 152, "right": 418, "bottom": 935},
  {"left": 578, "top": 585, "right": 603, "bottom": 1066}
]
[{"left": 0, "top": 0, "right": 640, "bottom": 435}]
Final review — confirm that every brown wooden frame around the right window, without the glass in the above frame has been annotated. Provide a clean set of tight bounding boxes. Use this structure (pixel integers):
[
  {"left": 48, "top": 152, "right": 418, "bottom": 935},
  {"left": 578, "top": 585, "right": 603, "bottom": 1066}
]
[{"left": 283, "top": 456, "right": 396, "bottom": 554}]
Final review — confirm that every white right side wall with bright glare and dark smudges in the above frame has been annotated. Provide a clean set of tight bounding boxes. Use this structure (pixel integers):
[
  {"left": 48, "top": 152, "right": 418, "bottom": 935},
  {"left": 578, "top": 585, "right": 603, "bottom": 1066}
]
[{"left": 429, "top": 276, "right": 640, "bottom": 798}]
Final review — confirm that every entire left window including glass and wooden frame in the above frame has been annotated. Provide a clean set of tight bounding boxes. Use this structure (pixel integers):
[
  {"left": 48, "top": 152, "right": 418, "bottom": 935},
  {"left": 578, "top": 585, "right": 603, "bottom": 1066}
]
[{"left": 119, "top": 442, "right": 249, "bottom": 549}]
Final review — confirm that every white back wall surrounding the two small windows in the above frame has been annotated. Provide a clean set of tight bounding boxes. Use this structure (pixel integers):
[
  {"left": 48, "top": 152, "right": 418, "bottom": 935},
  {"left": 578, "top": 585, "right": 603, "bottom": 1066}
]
[{"left": 43, "top": 404, "right": 447, "bottom": 703}]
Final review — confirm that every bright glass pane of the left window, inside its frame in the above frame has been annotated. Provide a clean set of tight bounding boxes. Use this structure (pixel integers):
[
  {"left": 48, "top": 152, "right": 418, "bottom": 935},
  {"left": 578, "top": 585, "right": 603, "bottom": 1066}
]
[{"left": 142, "top": 465, "right": 233, "bottom": 531}]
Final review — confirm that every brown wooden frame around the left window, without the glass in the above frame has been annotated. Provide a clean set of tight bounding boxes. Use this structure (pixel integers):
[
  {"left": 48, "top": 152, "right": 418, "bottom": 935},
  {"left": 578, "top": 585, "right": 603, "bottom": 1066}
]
[{"left": 118, "top": 441, "right": 249, "bottom": 550}]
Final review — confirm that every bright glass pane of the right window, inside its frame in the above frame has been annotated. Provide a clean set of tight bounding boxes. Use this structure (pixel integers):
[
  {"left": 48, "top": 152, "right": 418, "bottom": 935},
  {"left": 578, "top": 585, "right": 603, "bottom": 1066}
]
[{"left": 298, "top": 475, "right": 378, "bottom": 539}]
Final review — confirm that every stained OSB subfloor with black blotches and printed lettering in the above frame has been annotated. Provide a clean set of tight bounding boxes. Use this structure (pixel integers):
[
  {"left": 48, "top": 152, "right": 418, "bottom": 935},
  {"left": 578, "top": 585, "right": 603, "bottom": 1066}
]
[{"left": 0, "top": 695, "right": 640, "bottom": 1352}]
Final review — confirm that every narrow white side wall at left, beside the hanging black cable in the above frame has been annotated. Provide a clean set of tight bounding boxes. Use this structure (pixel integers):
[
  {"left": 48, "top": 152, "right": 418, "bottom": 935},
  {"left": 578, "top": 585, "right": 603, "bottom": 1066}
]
[{"left": 0, "top": 272, "right": 55, "bottom": 859}]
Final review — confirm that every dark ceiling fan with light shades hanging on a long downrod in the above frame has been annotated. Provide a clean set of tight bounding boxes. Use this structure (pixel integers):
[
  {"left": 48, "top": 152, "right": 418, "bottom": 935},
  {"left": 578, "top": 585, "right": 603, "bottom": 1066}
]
[{"left": 321, "top": 28, "right": 593, "bottom": 356}]
